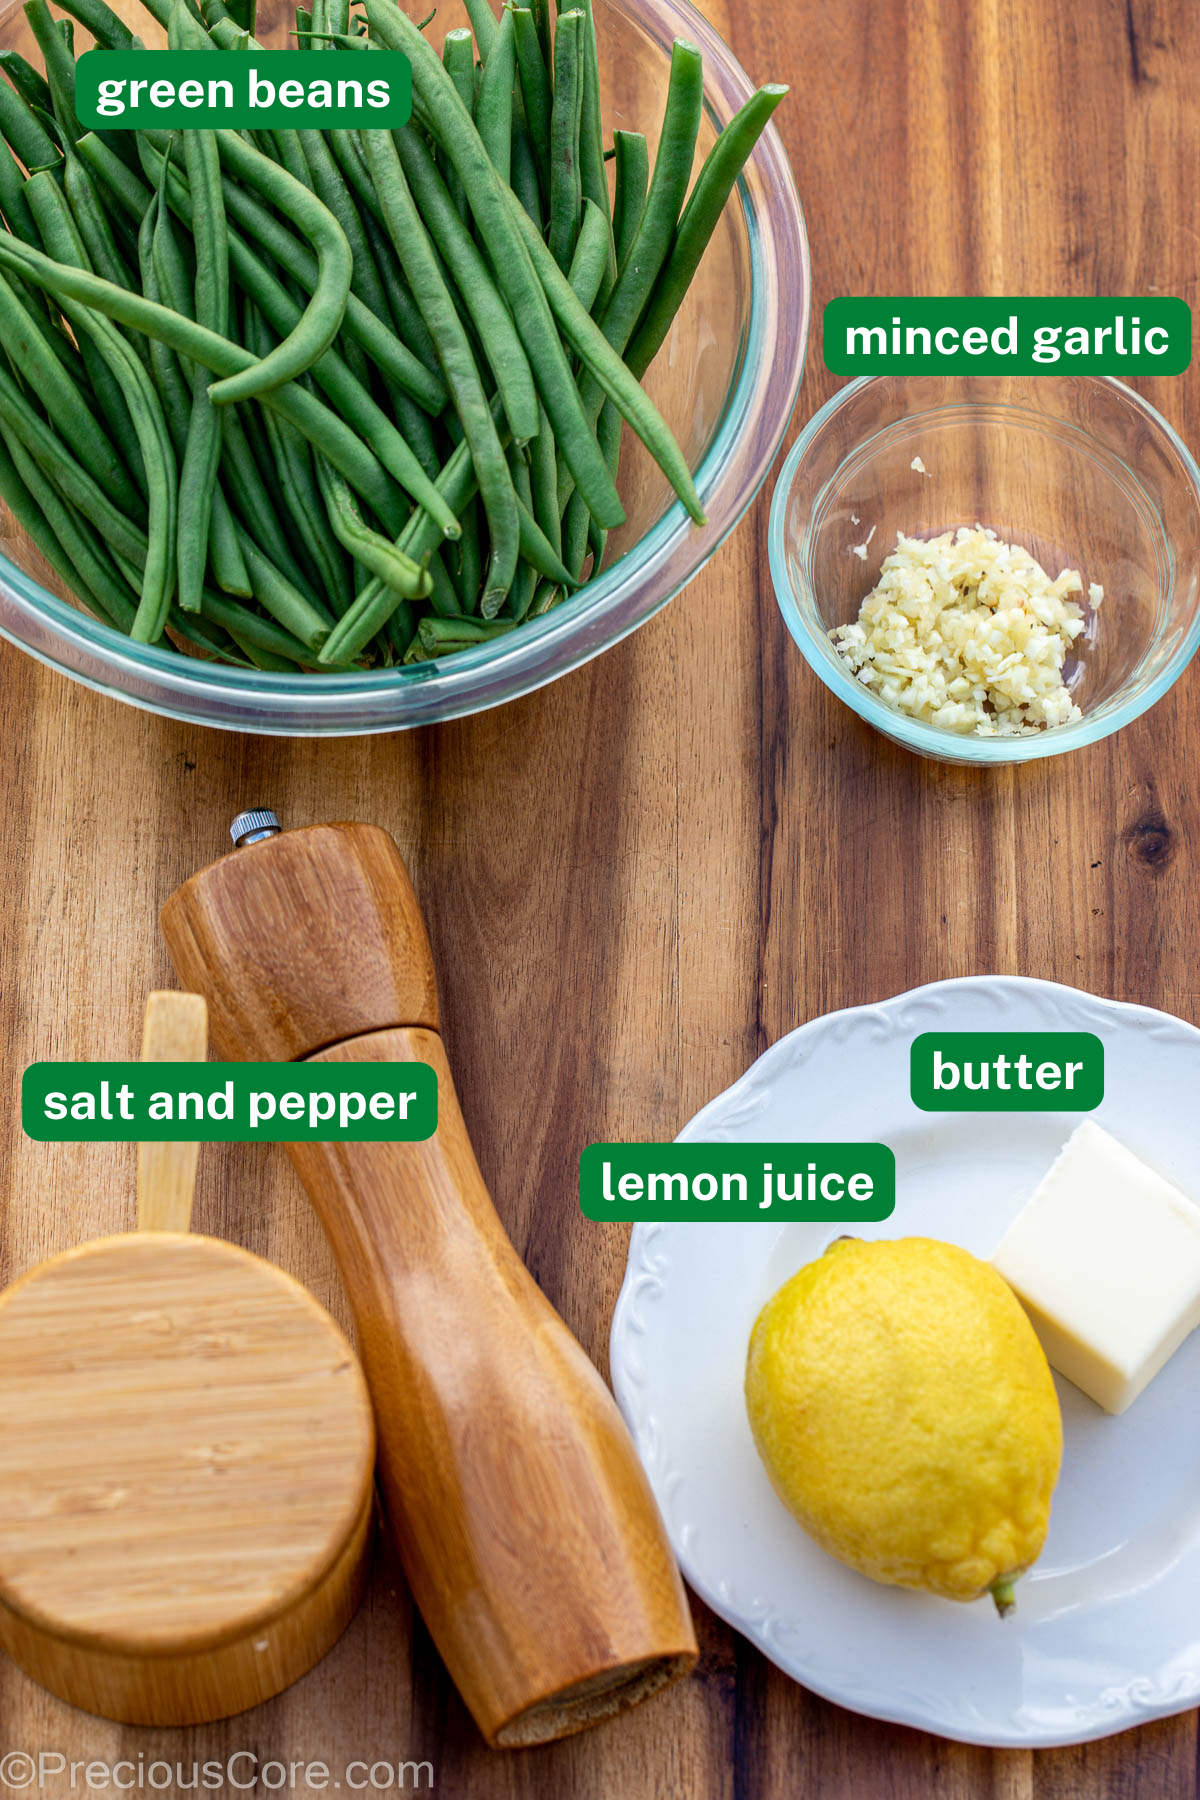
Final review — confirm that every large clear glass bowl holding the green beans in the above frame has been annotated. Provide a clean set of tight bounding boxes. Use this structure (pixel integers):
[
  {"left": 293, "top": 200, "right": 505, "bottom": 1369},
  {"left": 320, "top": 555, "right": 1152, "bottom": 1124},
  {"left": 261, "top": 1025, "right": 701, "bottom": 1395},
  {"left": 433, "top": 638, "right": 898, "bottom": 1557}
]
[{"left": 0, "top": 0, "right": 810, "bottom": 736}]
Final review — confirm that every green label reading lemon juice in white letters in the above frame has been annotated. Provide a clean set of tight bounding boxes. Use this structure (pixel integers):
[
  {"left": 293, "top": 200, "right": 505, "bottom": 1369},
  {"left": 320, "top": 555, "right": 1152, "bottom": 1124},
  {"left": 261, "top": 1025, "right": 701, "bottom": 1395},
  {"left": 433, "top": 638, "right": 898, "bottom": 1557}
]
[{"left": 579, "top": 1143, "right": 896, "bottom": 1220}]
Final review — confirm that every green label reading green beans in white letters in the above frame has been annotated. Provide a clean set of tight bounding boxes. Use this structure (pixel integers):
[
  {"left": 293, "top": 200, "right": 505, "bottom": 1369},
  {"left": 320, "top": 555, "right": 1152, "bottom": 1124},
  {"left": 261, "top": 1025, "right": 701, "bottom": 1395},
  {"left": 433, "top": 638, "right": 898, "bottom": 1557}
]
[{"left": 76, "top": 50, "right": 412, "bottom": 131}]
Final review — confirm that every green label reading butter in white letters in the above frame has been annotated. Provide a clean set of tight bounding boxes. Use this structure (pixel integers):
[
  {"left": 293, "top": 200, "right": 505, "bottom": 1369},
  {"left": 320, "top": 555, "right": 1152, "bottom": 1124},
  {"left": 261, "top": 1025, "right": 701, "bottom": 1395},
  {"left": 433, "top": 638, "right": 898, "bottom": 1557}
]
[{"left": 909, "top": 1031, "right": 1105, "bottom": 1112}]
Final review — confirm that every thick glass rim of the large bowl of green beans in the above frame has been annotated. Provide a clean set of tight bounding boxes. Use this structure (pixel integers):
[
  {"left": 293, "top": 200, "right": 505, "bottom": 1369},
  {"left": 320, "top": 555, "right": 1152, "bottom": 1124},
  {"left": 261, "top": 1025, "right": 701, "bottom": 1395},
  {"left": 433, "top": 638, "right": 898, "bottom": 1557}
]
[{"left": 0, "top": 0, "right": 811, "bottom": 736}]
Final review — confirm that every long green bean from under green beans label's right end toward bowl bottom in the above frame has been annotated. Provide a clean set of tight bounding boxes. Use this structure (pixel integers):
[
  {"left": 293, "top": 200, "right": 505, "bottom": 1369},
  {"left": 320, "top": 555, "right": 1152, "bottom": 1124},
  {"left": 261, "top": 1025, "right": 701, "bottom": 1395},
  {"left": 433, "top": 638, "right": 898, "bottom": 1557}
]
[{"left": 363, "top": 128, "right": 518, "bottom": 599}]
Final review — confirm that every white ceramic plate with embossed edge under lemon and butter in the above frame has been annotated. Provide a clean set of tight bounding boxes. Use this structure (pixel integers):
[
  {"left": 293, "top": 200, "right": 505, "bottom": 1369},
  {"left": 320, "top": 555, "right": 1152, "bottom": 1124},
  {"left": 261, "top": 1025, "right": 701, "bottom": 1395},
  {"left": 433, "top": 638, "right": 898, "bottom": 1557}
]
[{"left": 612, "top": 977, "right": 1200, "bottom": 1746}]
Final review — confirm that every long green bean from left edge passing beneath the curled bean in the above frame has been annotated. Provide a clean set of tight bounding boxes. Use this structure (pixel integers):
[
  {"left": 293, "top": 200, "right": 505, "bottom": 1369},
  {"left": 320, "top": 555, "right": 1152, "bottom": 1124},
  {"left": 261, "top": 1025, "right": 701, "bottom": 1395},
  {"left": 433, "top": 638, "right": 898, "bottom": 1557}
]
[{"left": 0, "top": 232, "right": 408, "bottom": 531}]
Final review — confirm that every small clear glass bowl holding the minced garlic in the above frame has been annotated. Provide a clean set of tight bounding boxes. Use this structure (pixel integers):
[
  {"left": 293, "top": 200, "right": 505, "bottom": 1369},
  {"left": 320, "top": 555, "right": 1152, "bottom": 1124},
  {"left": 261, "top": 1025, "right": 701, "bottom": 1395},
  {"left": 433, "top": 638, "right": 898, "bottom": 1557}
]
[{"left": 770, "top": 376, "right": 1200, "bottom": 765}]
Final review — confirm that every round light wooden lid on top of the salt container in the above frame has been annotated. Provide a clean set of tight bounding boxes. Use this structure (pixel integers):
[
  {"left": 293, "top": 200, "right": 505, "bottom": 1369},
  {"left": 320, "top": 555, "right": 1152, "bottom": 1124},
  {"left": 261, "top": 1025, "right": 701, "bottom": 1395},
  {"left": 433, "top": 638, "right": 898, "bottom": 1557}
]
[{"left": 0, "top": 1231, "right": 374, "bottom": 1654}]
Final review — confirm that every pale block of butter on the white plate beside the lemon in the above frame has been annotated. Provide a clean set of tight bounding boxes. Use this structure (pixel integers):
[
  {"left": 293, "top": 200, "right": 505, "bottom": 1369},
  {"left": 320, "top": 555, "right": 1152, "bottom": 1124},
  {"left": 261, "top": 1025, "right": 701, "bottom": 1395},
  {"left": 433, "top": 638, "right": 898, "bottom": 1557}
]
[{"left": 991, "top": 1120, "right": 1200, "bottom": 1413}]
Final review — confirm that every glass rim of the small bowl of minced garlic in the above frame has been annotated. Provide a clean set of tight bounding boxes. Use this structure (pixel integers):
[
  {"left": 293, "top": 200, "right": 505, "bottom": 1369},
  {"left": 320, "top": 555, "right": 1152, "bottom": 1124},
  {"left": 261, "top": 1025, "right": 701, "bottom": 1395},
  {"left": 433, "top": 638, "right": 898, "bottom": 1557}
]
[{"left": 766, "top": 374, "right": 1200, "bottom": 765}]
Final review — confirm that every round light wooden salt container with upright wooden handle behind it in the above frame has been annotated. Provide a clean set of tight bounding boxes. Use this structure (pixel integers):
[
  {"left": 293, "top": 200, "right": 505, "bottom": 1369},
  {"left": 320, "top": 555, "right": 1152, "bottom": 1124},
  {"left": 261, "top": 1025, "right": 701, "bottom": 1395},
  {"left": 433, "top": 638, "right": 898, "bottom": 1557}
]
[{"left": 0, "top": 994, "right": 374, "bottom": 1724}]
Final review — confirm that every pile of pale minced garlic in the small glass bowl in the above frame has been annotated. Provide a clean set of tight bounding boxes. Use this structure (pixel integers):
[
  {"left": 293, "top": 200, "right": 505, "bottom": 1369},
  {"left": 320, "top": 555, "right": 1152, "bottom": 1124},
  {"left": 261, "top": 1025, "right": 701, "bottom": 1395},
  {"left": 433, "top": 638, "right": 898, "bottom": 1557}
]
[{"left": 829, "top": 526, "right": 1103, "bottom": 738}]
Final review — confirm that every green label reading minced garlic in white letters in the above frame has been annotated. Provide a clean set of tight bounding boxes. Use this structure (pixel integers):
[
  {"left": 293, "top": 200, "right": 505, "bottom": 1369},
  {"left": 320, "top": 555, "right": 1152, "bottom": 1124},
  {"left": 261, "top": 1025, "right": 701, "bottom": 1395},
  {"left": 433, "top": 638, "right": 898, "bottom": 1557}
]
[{"left": 824, "top": 293, "right": 1191, "bottom": 374}]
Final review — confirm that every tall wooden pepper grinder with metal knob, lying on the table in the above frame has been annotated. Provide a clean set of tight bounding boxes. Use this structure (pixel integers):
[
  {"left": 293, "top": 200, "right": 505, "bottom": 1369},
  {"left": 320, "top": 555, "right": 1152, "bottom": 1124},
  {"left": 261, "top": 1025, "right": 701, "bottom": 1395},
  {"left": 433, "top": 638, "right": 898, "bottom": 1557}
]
[{"left": 162, "top": 812, "right": 696, "bottom": 1746}]
